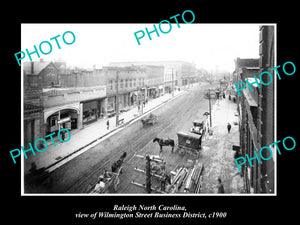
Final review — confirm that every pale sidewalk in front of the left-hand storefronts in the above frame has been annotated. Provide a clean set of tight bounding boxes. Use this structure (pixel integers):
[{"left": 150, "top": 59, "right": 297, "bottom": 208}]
[{"left": 24, "top": 90, "right": 186, "bottom": 173}]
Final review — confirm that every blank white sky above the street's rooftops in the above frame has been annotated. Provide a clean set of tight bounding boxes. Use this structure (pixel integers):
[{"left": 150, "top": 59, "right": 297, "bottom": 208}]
[{"left": 21, "top": 23, "right": 261, "bottom": 72}]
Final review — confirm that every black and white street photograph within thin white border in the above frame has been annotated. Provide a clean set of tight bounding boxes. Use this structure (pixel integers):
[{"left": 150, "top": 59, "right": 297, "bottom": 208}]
[{"left": 19, "top": 23, "right": 276, "bottom": 195}]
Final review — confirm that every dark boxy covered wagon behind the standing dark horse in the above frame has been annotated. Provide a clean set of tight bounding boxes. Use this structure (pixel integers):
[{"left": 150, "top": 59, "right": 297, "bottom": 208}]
[{"left": 176, "top": 131, "right": 202, "bottom": 158}]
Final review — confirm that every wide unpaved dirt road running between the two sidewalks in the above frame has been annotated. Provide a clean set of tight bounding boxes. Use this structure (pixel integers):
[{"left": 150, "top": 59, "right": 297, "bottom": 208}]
[{"left": 31, "top": 84, "right": 213, "bottom": 193}]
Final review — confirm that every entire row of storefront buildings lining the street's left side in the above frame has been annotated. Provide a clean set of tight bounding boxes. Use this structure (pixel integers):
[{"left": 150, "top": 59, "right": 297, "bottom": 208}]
[{"left": 23, "top": 60, "right": 197, "bottom": 146}]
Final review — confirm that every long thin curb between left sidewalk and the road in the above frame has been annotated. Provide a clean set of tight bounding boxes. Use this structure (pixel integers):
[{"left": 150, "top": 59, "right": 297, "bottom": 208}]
[{"left": 44, "top": 91, "right": 187, "bottom": 170}]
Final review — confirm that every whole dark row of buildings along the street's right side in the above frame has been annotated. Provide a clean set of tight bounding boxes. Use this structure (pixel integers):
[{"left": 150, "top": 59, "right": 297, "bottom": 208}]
[{"left": 235, "top": 26, "right": 275, "bottom": 193}]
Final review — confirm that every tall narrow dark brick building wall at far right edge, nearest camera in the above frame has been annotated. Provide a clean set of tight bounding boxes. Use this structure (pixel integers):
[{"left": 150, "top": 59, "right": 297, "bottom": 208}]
[{"left": 258, "top": 26, "right": 277, "bottom": 193}]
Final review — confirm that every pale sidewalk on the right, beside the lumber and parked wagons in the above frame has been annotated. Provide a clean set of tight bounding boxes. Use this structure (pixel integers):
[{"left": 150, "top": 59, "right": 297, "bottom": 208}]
[{"left": 202, "top": 96, "right": 243, "bottom": 194}]
